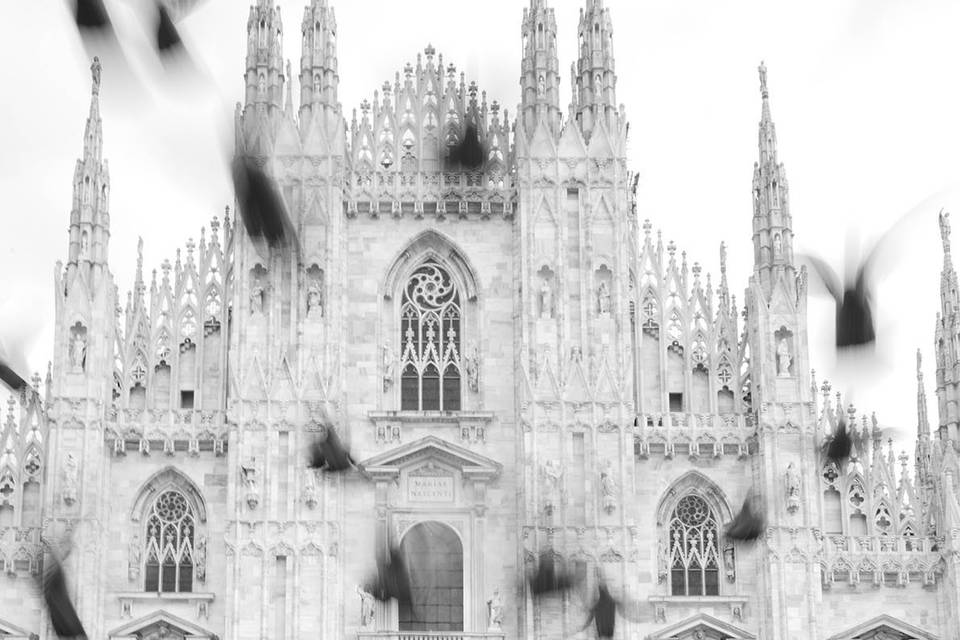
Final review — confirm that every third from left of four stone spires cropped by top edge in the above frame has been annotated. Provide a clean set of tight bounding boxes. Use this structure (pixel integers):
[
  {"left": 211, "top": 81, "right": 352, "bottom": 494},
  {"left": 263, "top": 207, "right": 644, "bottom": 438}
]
[{"left": 520, "top": 0, "right": 560, "bottom": 135}]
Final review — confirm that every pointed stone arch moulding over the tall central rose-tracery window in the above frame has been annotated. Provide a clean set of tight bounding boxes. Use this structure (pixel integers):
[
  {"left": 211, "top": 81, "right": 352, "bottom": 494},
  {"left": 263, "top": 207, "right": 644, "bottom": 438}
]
[{"left": 383, "top": 229, "right": 479, "bottom": 302}]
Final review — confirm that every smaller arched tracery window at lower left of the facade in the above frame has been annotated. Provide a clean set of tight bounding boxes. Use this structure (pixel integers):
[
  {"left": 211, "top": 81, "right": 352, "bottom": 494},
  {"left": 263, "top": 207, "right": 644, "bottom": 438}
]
[{"left": 144, "top": 489, "right": 196, "bottom": 593}]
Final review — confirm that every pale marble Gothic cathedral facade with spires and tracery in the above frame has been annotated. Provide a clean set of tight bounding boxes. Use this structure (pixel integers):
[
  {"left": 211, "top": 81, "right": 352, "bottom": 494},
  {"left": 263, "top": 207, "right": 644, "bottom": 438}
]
[{"left": 0, "top": 0, "right": 960, "bottom": 640}]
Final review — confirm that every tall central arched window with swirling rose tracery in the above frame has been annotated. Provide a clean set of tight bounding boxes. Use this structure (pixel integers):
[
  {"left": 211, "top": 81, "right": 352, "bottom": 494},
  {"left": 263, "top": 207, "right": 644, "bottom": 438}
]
[{"left": 400, "top": 260, "right": 461, "bottom": 411}]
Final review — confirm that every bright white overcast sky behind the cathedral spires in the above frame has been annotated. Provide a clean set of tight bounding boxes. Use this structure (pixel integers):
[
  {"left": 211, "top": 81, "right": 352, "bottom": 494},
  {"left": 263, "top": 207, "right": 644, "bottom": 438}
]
[{"left": 0, "top": 0, "right": 960, "bottom": 452}]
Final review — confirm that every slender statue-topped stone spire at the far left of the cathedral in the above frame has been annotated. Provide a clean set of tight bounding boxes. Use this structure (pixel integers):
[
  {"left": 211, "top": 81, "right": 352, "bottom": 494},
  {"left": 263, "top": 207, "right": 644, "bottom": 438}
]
[{"left": 67, "top": 58, "right": 110, "bottom": 266}]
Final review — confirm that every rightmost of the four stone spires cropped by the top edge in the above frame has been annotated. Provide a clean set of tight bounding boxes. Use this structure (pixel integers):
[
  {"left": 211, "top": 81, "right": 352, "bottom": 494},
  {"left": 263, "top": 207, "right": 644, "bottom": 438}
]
[{"left": 572, "top": 0, "right": 617, "bottom": 137}]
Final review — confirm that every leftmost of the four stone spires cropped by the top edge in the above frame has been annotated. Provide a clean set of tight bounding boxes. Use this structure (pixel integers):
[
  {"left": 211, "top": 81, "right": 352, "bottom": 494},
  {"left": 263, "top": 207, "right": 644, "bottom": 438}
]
[{"left": 246, "top": 0, "right": 286, "bottom": 109}]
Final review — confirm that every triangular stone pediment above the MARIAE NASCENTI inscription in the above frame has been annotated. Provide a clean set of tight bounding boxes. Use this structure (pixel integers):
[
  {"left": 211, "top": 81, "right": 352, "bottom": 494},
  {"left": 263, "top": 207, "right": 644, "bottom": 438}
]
[{"left": 360, "top": 436, "right": 502, "bottom": 480}]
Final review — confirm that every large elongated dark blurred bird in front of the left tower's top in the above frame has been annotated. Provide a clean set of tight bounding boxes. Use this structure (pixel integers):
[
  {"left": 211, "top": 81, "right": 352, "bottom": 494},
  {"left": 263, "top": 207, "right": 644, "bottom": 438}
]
[{"left": 232, "top": 154, "right": 298, "bottom": 253}]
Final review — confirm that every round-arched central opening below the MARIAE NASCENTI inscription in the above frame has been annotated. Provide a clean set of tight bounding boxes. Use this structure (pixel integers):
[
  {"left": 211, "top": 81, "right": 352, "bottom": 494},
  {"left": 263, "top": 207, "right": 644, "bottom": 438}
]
[{"left": 399, "top": 522, "right": 463, "bottom": 631}]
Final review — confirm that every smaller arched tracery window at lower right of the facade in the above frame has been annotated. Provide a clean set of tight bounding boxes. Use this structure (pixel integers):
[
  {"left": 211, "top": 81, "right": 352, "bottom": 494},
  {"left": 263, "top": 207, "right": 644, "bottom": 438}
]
[{"left": 669, "top": 495, "right": 720, "bottom": 596}]
